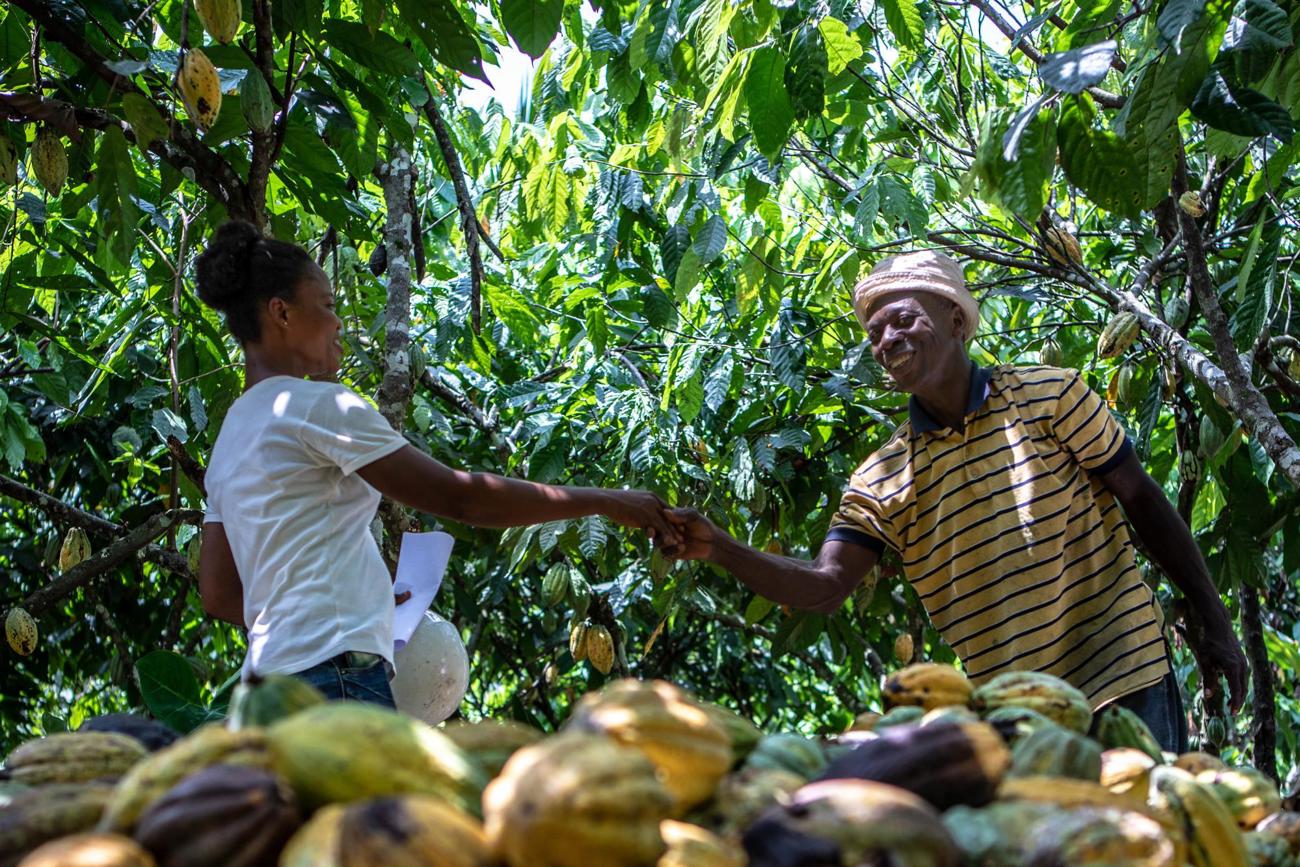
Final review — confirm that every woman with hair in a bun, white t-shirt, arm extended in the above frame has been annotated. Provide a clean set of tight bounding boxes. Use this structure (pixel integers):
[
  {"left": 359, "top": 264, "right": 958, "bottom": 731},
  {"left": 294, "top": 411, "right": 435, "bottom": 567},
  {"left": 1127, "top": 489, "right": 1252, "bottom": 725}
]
[{"left": 196, "top": 221, "right": 680, "bottom": 706}]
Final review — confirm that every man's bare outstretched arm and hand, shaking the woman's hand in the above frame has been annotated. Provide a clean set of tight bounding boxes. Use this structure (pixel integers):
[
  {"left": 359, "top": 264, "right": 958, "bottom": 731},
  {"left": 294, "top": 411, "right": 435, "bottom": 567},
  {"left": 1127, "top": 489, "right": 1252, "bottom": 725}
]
[{"left": 664, "top": 508, "right": 879, "bottom": 614}]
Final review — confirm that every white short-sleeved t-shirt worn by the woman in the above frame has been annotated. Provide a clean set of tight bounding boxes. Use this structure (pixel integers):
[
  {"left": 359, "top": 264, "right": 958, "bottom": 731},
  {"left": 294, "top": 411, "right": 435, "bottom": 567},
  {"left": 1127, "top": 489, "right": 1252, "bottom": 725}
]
[{"left": 204, "top": 376, "right": 407, "bottom": 675}]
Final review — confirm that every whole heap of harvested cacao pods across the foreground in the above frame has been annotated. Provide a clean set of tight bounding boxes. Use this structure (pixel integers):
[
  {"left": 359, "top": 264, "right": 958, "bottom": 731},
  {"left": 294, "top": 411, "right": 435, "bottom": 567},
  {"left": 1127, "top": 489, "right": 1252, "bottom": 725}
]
[{"left": 0, "top": 663, "right": 1300, "bottom": 867}]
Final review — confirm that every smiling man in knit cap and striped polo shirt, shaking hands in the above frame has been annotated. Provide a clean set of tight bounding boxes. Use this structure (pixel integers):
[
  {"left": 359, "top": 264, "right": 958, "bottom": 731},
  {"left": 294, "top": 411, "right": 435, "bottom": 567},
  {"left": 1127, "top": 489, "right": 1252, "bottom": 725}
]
[{"left": 671, "top": 252, "right": 1245, "bottom": 751}]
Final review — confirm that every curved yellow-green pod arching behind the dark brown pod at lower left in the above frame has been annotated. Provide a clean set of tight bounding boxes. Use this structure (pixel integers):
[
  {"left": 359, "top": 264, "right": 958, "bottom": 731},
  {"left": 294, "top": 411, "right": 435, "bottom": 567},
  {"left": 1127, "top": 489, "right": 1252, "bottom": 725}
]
[{"left": 99, "top": 724, "right": 270, "bottom": 833}]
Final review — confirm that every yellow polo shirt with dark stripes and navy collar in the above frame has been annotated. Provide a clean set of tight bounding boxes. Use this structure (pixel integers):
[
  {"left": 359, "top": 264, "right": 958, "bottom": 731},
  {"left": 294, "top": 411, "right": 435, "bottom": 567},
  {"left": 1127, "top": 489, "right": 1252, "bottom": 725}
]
[{"left": 827, "top": 365, "right": 1169, "bottom": 707}]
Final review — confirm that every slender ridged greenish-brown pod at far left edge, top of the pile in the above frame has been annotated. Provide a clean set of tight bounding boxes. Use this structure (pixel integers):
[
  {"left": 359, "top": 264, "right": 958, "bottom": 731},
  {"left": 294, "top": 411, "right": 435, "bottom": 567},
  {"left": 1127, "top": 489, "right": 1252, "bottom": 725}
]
[{"left": 4, "top": 732, "right": 148, "bottom": 785}]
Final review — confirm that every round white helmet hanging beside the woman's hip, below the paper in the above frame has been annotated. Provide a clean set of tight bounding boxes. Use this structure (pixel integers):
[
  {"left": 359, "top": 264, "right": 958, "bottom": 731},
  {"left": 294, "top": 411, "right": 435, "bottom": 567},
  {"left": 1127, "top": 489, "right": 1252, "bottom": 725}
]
[{"left": 391, "top": 611, "right": 469, "bottom": 725}]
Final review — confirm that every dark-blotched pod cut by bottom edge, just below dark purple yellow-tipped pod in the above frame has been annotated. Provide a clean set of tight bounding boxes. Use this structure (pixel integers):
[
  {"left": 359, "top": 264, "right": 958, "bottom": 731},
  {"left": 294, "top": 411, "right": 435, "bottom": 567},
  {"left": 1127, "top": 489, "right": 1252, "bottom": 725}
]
[{"left": 742, "top": 780, "right": 961, "bottom": 867}]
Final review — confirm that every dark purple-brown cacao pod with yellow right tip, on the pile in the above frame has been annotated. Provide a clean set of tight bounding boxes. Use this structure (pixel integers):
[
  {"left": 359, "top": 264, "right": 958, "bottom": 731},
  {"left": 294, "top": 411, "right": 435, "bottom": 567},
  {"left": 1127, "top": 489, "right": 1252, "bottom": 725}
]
[{"left": 819, "top": 723, "right": 1011, "bottom": 810}]
